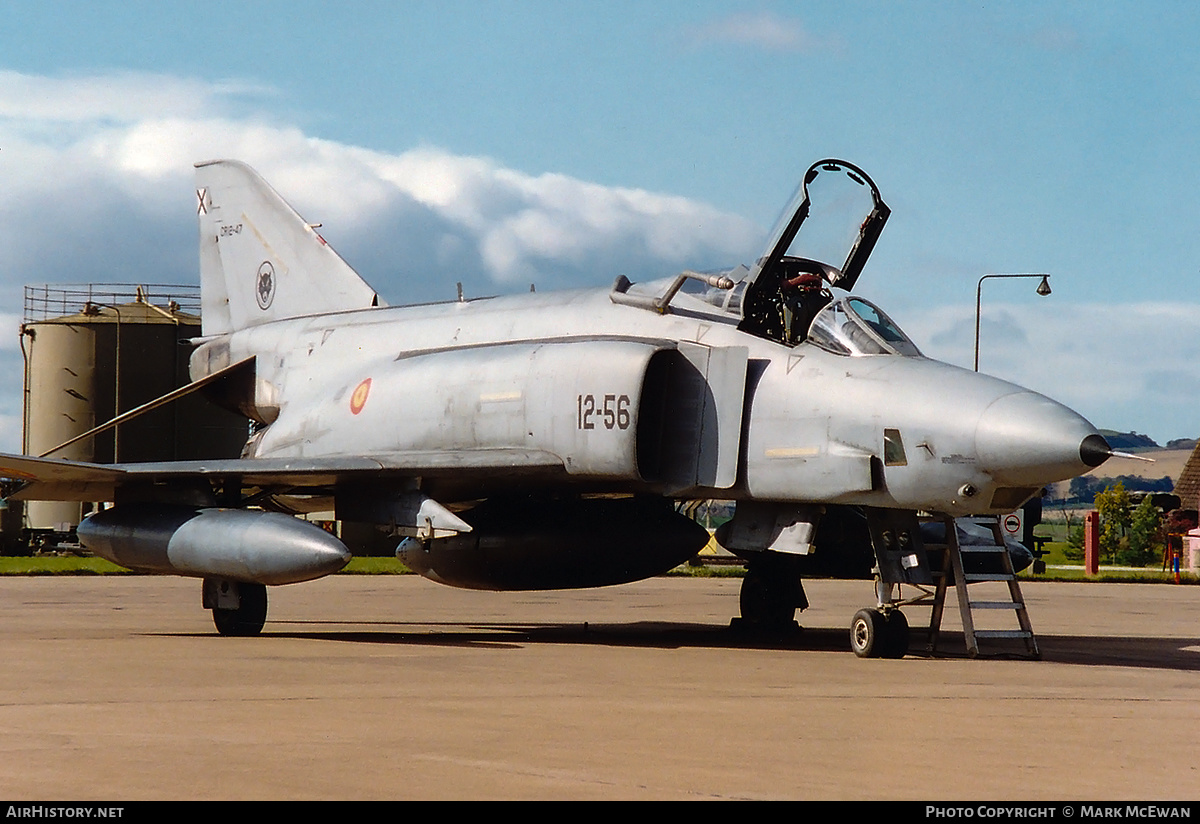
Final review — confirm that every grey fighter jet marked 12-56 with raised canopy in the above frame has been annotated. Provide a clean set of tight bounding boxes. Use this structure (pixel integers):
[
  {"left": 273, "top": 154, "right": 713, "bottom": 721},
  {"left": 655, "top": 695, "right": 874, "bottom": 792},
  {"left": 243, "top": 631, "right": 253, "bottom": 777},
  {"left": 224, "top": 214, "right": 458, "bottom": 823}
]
[{"left": 0, "top": 160, "right": 1114, "bottom": 655}]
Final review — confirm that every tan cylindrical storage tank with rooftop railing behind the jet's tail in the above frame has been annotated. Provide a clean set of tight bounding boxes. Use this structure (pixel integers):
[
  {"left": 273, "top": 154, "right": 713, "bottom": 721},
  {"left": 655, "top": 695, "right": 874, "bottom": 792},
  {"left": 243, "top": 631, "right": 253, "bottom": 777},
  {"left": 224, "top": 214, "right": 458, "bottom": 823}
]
[{"left": 20, "top": 284, "right": 247, "bottom": 531}]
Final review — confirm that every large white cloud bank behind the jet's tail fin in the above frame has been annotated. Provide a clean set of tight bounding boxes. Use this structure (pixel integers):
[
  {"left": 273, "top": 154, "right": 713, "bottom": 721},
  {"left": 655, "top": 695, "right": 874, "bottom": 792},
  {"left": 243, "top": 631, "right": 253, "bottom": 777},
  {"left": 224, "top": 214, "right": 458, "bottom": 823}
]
[{"left": 0, "top": 71, "right": 761, "bottom": 449}]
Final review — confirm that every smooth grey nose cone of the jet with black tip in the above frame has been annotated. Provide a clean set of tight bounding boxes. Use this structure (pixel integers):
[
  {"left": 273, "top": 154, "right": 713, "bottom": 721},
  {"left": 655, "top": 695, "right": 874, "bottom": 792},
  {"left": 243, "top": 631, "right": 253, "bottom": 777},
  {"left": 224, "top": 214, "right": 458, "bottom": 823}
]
[{"left": 976, "top": 392, "right": 1111, "bottom": 486}]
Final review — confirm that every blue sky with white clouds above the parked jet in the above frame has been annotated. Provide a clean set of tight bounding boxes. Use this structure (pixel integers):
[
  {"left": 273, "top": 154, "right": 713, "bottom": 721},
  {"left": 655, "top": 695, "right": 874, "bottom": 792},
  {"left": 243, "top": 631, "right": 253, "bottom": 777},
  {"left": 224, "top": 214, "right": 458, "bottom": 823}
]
[{"left": 0, "top": 0, "right": 1200, "bottom": 451}]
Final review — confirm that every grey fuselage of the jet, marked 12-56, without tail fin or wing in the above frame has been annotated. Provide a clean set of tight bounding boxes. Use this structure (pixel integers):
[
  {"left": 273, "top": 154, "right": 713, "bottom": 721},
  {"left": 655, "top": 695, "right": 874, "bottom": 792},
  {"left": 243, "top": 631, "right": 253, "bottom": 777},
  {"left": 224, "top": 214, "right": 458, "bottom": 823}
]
[{"left": 192, "top": 284, "right": 1096, "bottom": 515}]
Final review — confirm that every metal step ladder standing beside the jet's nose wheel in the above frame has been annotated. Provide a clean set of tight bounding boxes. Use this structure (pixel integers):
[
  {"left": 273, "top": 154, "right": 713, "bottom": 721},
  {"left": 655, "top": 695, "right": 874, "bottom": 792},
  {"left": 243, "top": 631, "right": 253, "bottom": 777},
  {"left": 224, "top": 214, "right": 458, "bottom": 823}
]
[{"left": 928, "top": 517, "right": 1042, "bottom": 658}]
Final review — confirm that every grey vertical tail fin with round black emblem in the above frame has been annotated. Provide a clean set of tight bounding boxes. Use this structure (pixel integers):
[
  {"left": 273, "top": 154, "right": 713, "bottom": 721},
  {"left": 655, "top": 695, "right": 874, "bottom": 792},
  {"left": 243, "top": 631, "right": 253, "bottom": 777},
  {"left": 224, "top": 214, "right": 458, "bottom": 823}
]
[{"left": 196, "top": 161, "right": 380, "bottom": 336}]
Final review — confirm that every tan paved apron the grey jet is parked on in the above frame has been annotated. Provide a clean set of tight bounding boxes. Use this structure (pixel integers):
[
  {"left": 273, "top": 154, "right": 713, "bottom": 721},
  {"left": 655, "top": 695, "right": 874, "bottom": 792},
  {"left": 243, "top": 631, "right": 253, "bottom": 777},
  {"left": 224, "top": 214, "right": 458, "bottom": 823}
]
[{"left": 0, "top": 576, "right": 1200, "bottom": 801}]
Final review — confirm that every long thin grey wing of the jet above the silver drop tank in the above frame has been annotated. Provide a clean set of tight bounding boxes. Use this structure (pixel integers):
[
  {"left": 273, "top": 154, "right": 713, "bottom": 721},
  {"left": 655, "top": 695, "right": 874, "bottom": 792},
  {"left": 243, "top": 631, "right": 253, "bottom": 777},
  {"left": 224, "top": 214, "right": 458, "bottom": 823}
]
[{"left": 0, "top": 449, "right": 563, "bottom": 501}]
